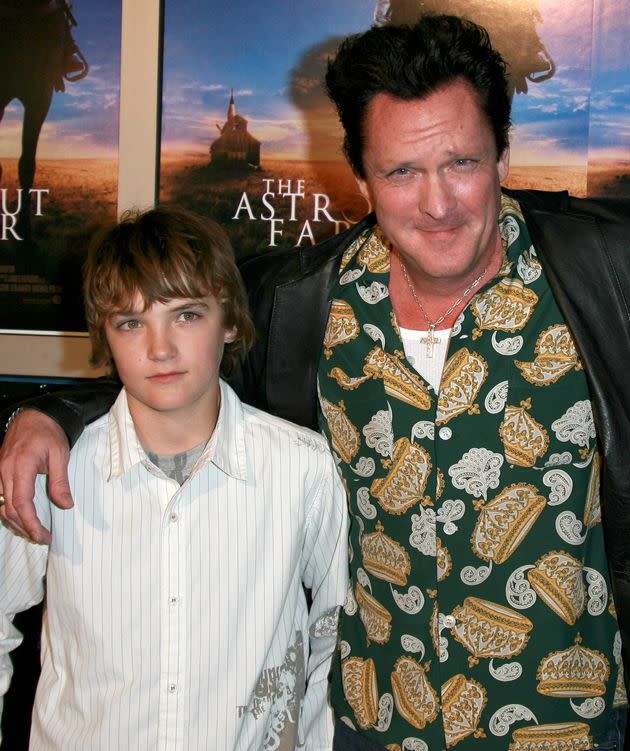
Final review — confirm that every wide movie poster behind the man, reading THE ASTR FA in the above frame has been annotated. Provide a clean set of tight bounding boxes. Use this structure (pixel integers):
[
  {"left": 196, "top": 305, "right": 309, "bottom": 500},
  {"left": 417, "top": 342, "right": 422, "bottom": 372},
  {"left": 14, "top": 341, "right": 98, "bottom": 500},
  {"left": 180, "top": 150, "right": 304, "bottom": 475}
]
[{"left": 160, "top": 0, "right": 630, "bottom": 259}]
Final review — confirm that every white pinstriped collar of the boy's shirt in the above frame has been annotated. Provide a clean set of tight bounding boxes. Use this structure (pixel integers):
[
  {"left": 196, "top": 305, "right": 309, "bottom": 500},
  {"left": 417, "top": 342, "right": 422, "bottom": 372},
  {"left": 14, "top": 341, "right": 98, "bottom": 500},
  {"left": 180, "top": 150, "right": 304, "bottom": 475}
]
[{"left": 105, "top": 381, "right": 247, "bottom": 480}]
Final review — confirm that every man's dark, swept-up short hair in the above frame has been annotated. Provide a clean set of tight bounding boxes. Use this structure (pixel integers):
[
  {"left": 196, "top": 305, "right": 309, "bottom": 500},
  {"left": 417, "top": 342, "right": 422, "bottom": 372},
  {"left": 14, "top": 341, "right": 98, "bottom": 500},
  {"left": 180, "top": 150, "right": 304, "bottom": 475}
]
[{"left": 326, "top": 15, "right": 511, "bottom": 178}]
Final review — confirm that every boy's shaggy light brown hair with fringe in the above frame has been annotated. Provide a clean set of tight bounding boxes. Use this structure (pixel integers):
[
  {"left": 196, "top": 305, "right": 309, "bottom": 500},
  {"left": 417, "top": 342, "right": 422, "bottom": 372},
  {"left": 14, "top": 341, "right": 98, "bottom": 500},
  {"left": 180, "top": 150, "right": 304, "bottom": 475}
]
[{"left": 83, "top": 206, "right": 254, "bottom": 376}]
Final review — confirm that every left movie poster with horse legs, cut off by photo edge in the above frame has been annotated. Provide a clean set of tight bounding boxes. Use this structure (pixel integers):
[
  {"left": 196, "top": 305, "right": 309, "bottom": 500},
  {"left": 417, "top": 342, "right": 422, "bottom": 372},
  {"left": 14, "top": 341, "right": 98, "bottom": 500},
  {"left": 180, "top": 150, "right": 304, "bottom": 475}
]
[{"left": 0, "top": 0, "right": 122, "bottom": 333}]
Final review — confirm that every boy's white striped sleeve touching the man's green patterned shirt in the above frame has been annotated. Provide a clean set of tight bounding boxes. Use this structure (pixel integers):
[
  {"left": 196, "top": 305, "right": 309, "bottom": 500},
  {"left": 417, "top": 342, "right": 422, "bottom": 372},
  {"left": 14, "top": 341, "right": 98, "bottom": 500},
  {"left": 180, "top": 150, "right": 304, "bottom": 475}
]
[{"left": 301, "top": 450, "right": 348, "bottom": 751}]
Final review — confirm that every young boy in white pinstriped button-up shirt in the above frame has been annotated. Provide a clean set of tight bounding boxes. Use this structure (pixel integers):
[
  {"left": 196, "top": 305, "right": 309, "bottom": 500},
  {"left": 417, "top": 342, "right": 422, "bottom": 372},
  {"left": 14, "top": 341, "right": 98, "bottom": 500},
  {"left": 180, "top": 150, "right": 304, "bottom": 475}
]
[{"left": 0, "top": 207, "right": 347, "bottom": 751}]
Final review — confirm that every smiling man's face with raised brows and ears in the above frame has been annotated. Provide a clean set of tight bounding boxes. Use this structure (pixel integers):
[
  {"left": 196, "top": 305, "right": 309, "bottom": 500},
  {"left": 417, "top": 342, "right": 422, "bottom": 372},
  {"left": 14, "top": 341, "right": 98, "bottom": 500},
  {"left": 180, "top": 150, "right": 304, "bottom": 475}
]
[{"left": 358, "top": 80, "right": 509, "bottom": 289}]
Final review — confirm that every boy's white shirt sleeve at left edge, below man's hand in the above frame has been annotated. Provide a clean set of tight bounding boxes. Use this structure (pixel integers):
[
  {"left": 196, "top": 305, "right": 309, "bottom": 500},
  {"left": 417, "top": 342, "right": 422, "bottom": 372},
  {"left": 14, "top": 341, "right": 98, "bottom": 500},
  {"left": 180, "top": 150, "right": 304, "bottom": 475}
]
[{"left": 0, "top": 475, "right": 50, "bottom": 744}]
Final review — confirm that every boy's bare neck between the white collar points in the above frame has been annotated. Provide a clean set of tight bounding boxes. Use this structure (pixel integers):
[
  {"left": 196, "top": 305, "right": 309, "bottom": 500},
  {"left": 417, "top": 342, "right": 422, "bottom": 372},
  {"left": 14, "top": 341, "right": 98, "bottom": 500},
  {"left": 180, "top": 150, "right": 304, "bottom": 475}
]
[{"left": 127, "top": 384, "right": 221, "bottom": 456}]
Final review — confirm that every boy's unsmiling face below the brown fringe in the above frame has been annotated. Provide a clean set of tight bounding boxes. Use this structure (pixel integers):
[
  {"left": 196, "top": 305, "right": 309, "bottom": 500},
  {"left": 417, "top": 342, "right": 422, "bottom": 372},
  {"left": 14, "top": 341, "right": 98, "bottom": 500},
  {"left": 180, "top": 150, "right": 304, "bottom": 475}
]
[{"left": 105, "top": 293, "right": 236, "bottom": 428}]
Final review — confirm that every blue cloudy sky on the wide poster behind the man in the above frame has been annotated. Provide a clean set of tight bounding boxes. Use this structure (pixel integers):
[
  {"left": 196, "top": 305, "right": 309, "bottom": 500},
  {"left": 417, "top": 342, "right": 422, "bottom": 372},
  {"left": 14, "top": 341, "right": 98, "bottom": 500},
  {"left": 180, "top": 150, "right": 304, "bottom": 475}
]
[{"left": 162, "top": 0, "right": 630, "bottom": 164}]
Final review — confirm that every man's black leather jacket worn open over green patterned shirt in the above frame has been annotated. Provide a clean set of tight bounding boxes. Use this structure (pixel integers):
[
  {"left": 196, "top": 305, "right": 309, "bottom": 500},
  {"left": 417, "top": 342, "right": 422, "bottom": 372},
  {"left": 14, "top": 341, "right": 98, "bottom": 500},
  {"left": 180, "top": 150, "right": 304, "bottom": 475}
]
[{"left": 8, "top": 191, "right": 630, "bottom": 700}]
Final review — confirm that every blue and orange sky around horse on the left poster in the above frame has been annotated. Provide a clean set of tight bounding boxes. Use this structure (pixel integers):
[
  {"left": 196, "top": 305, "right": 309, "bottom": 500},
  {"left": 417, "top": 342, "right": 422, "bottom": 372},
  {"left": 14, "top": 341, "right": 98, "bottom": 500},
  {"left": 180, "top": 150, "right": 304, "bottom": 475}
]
[{"left": 0, "top": 0, "right": 122, "bottom": 159}]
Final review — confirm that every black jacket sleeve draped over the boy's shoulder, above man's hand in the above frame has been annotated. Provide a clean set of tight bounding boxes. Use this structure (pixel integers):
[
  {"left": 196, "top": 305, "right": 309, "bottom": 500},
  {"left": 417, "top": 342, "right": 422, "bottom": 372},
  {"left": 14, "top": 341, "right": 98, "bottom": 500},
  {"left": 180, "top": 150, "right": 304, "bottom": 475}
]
[{"left": 0, "top": 378, "right": 120, "bottom": 446}]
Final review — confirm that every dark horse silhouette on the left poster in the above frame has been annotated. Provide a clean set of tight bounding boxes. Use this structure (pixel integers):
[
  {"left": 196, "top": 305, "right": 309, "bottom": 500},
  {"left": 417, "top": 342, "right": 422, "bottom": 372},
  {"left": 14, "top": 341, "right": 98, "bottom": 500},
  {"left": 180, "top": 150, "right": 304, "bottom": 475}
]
[{"left": 0, "top": 0, "right": 88, "bottom": 239}]
